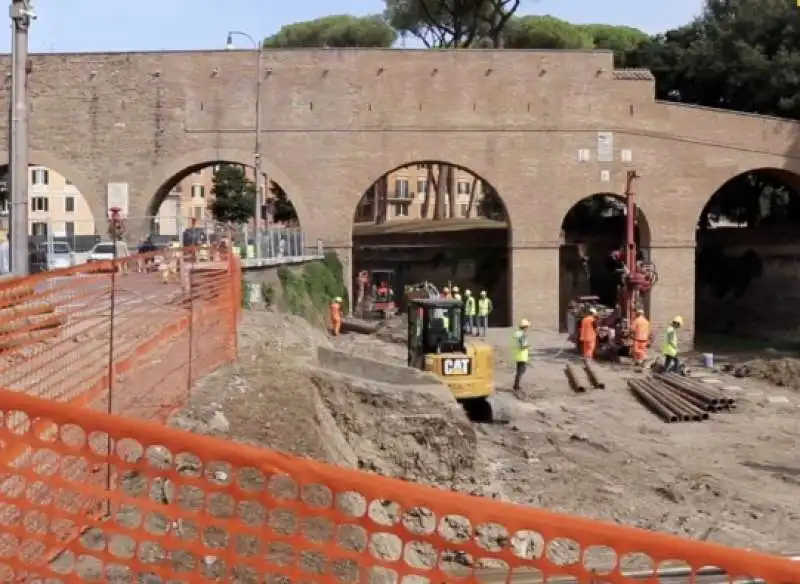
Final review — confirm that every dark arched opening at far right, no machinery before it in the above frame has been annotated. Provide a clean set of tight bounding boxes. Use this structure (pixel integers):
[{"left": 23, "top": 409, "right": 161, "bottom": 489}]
[{"left": 695, "top": 168, "right": 800, "bottom": 346}]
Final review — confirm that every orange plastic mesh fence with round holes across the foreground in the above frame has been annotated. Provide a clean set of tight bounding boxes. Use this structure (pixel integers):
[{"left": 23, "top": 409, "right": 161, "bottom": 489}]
[{"left": 0, "top": 392, "right": 800, "bottom": 584}]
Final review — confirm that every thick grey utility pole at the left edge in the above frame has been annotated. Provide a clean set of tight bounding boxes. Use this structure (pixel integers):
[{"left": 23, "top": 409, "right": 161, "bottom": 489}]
[{"left": 8, "top": 0, "right": 36, "bottom": 276}]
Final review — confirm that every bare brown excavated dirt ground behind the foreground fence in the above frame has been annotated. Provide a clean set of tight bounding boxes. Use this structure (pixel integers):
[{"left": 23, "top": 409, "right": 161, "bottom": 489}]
[{"left": 61, "top": 312, "right": 800, "bottom": 576}]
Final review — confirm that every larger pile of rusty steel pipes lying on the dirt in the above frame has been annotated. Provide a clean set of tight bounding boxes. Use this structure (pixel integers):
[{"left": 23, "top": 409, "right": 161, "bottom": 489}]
[{"left": 628, "top": 373, "right": 736, "bottom": 424}]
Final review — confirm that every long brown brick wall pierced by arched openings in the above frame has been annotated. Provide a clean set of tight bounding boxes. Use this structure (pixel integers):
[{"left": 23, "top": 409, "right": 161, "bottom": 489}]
[{"left": 0, "top": 50, "right": 800, "bottom": 338}]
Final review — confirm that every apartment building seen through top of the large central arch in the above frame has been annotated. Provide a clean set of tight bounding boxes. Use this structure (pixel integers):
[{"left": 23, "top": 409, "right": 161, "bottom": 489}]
[{"left": 355, "top": 164, "right": 488, "bottom": 222}]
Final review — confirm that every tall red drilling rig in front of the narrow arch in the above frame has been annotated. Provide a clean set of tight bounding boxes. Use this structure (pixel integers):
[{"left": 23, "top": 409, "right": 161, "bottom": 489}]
[{"left": 567, "top": 170, "right": 658, "bottom": 359}]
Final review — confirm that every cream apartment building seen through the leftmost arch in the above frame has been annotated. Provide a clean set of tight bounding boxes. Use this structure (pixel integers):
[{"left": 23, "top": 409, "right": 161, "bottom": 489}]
[{"left": 0, "top": 166, "right": 95, "bottom": 238}]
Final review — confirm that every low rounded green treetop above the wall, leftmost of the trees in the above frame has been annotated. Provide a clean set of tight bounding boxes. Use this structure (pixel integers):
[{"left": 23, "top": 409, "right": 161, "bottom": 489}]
[{"left": 264, "top": 14, "right": 397, "bottom": 48}]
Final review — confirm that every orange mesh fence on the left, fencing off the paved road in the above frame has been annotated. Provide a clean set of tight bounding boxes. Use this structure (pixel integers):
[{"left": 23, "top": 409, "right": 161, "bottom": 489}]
[{"left": 0, "top": 249, "right": 239, "bottom": 426}]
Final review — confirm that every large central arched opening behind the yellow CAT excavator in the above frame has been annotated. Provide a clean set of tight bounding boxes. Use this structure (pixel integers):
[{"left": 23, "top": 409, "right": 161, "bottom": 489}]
[{"left": 353, "top": 160, "right": 512, "bottom": 327}]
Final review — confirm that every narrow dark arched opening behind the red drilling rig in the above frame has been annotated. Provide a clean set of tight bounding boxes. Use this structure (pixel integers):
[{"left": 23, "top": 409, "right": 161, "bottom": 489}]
[{"left": 558, "top": 193, "right": 650, "bottom": 332}]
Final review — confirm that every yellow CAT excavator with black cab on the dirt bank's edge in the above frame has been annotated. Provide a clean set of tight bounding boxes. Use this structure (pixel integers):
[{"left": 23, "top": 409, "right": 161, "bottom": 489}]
[{"left": 408, "top": 298, "right": 494, "bottom": 422}]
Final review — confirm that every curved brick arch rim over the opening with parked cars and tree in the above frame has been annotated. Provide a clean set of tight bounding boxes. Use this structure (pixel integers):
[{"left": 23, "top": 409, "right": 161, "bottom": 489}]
[{"left": 141, "top": 148, "right": 310, "bottom": 225}]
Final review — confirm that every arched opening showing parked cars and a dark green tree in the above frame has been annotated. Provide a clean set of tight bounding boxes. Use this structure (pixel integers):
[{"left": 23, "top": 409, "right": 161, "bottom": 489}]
[{"left": 145, "top": 160, "right": 300, "bottom": 257}]
